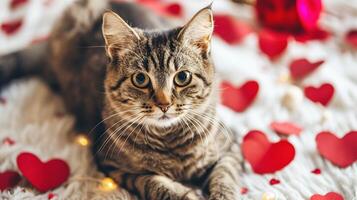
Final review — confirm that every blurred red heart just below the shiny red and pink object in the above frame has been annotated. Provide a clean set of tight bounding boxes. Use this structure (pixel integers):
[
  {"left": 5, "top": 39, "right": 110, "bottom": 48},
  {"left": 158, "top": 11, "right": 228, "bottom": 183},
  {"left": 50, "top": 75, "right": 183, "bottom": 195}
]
[{"left": 258, "top": 29, "right": 288, "bottom": 59}]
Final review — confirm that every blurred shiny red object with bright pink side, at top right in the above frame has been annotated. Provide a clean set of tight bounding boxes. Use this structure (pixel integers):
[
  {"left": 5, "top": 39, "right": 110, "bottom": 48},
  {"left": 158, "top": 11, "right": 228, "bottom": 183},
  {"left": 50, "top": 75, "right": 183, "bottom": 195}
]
[{"left": 256, "top": 0, "right": 322, "bottom": 33}]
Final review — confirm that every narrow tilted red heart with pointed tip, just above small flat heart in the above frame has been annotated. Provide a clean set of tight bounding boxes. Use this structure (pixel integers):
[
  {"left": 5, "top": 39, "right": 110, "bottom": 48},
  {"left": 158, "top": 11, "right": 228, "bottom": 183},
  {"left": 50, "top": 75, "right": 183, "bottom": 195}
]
[{"left": 290, "top": 58, "right": 325, "bottom": 79}]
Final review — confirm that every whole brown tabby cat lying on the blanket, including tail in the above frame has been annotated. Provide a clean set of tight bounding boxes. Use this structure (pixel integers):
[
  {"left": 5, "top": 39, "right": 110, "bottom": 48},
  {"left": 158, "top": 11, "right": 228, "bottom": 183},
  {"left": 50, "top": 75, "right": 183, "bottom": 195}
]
[{"left": 0, "top": 0, "right": 240, "bottom": 200}]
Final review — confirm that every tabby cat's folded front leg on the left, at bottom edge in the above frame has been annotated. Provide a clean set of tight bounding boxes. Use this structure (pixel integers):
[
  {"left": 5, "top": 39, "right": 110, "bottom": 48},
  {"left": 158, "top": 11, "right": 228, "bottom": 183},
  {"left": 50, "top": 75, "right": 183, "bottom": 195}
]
[{"left": 121, "top": 175, "right": 202, "bottom": 200}]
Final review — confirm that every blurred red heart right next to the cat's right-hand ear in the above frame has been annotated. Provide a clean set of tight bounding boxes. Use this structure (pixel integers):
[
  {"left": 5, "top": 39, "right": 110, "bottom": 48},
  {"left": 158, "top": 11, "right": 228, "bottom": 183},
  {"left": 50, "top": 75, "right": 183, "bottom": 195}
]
[{"left": 214, "top": 14, "right": 252, "bottom": 44}]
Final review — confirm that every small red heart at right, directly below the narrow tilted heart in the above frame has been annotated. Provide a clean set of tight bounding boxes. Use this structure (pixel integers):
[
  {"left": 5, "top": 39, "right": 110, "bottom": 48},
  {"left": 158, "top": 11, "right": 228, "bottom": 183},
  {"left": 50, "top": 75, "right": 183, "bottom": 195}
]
[{"left": 304, "top": 83, "right": 335, "bottom": 106}]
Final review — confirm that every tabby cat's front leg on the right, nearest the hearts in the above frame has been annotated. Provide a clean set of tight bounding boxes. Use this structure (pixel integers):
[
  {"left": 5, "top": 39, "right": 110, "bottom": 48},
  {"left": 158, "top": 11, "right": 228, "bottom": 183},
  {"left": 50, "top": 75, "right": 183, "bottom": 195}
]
[{"left": 206, "top": 145, "right": 241, "bottom": 200}]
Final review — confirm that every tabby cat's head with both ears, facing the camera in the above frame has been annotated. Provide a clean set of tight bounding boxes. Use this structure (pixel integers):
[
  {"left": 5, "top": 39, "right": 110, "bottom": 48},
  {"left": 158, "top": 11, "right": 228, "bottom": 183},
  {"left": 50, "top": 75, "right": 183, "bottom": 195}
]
[{"left": 103, "top": 7, "right": 214, "bottom": 127}]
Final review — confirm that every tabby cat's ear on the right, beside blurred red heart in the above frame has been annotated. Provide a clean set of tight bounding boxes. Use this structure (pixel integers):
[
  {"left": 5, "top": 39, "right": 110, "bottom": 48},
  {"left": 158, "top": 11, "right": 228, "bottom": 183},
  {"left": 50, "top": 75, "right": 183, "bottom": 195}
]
[{"left": 178, "top": 4, "right": 214, "bottom": 53}]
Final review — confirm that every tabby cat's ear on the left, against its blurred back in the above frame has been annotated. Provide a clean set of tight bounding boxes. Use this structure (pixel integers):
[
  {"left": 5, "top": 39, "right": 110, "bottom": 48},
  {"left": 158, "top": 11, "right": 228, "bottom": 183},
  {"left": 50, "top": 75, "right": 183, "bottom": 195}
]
[{"left": 102, "top": 11, "right": 140, "bottom": 57}]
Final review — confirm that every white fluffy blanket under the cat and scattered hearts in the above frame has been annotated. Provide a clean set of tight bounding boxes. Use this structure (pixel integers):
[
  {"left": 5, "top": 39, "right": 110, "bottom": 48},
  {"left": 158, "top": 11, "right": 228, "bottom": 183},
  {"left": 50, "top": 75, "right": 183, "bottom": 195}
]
[{"left": 0, "top": 0, "right": 357, "bottom": 200}]
